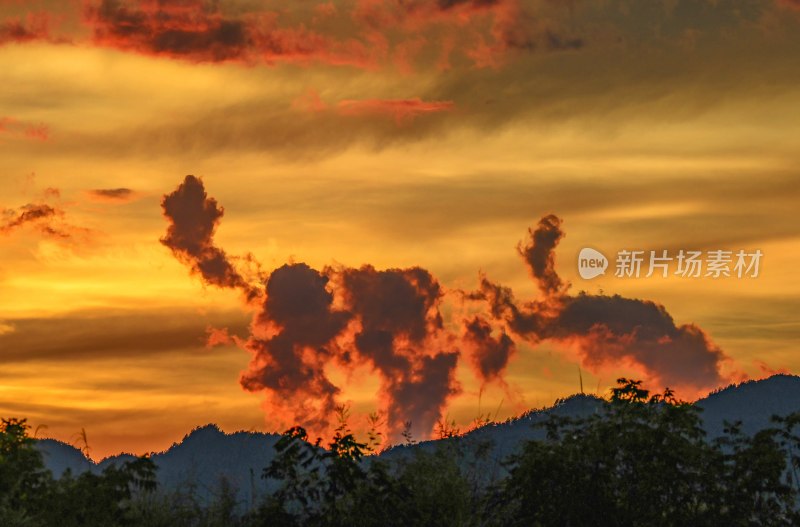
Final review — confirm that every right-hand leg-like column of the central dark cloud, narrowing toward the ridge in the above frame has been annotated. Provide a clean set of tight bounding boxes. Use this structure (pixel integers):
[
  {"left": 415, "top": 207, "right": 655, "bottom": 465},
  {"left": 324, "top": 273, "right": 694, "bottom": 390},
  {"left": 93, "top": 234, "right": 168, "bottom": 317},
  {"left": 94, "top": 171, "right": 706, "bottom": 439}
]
[{"left": 340, "top": 266, "right": 459, "bottom": 437}]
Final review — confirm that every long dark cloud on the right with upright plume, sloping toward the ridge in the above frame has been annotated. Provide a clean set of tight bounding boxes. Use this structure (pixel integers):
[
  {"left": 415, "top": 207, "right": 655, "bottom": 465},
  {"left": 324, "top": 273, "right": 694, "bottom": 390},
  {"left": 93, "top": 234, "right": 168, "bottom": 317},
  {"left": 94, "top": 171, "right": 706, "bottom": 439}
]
[{"left": 469, "top": 216, "right": 728, "bottom": 391}]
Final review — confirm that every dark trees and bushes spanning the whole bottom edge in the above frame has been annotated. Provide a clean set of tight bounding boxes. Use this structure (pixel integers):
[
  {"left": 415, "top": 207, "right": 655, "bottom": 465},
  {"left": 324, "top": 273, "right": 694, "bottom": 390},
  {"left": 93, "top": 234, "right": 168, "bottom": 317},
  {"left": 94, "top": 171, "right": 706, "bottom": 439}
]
[{"left": 0, "top": 379, "right": 800, "bottom": 527}]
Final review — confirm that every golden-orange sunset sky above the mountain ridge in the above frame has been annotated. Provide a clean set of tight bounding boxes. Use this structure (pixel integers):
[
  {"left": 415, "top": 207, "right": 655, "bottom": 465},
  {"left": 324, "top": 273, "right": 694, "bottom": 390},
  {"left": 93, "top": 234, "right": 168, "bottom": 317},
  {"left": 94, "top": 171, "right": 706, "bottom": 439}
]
[{"left": 0, "top": 0, "right": 800, "bottom": 459}]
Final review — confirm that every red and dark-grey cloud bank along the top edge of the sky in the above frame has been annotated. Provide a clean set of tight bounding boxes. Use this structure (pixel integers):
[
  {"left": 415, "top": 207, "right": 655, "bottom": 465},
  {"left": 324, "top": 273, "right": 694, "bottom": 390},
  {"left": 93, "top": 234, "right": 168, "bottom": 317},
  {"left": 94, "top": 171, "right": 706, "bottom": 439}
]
[{"left": 84, "top": 0, "right": 552, "bottom": 72}]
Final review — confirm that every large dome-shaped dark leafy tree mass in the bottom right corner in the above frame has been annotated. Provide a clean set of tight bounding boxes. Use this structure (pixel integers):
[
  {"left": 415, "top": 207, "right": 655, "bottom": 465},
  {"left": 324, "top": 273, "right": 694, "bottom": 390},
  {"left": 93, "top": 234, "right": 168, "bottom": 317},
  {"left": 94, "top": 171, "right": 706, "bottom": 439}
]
[{"left": 490, "top": 379, "right": 800, "bottom": 527}]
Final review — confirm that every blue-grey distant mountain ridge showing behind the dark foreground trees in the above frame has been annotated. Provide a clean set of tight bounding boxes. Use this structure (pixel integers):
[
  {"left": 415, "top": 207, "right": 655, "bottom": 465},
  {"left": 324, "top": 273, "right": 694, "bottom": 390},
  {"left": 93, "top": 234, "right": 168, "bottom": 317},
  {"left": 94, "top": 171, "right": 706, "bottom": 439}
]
[{"left": 38, "top": 375, "right": 800, "bottom": 504}]
